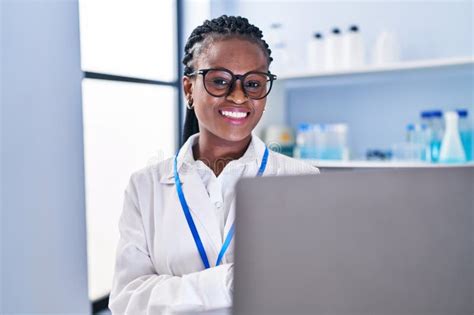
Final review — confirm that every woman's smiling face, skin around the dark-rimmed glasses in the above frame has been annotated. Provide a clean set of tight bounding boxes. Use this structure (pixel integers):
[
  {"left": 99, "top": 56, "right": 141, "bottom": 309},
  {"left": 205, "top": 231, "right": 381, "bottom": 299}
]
[{"left": 183, "top": 38, "right": 268, "bottom": 143}]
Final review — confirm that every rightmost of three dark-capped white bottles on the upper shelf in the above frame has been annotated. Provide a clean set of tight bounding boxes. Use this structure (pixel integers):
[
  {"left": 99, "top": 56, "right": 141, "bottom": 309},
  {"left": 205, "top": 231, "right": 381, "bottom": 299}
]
[{"left": 342, "top": 25, "right": 365, "bottom": 69}]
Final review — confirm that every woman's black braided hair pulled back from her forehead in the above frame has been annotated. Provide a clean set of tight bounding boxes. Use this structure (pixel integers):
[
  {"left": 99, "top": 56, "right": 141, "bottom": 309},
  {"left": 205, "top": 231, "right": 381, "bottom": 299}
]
[{"left": 183, "top": 15, "right": 273, "bottom": 143}]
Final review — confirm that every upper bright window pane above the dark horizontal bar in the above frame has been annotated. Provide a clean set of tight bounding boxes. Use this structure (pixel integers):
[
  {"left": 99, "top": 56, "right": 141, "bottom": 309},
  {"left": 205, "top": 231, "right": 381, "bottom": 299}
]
[{"left": 79, "top": 0, "right": 178, "bottom": 82}]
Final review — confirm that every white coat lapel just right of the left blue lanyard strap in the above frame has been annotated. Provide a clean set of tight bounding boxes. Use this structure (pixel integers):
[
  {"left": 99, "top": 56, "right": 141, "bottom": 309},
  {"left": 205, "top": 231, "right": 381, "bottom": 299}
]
[{"left": 180, "top": 171, "right": 222, "bottom": 266}]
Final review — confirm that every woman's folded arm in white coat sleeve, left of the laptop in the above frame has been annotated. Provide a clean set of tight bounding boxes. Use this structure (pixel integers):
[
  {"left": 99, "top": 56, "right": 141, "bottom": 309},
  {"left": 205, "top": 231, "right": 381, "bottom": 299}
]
[{"left": 109, "top": 178, "right": 233, "bottom": 315}]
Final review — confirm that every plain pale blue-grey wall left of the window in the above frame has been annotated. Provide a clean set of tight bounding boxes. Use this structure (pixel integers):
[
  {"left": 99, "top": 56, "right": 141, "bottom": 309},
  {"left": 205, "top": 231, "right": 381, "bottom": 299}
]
[{"left": 0, "top": 0, "right": 90, "bottom": 314}]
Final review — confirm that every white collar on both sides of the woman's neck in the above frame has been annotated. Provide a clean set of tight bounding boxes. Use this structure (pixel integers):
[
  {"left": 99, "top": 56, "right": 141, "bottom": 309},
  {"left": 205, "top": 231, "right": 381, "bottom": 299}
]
[{"left": 160, "top": 133, "right": 265, "bottom": 184}]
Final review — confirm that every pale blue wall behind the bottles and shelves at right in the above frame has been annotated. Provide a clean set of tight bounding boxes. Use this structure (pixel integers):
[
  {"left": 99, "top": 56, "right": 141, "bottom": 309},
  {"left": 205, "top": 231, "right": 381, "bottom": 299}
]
[{"left": 212, "top": 0, "right": 474, "bottom": 158}]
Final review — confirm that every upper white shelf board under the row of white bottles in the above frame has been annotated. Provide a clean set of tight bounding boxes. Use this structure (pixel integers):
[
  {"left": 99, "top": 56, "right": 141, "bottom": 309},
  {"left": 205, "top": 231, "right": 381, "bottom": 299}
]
[{"left": 278, "top": 56, "right": 474, "bottom": 87}]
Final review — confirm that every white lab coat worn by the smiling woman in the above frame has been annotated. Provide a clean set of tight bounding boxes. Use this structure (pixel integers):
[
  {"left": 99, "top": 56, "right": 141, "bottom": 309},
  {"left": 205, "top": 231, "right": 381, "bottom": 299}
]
[{"left": 109, "top": 136, "right": 318, "bottom": 315}]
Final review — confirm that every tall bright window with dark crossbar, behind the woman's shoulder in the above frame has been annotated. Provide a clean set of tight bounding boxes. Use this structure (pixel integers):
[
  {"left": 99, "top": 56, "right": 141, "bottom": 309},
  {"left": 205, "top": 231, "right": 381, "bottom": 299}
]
[{"left": 79, "top": 0, "right": 182, "bottom": 301}]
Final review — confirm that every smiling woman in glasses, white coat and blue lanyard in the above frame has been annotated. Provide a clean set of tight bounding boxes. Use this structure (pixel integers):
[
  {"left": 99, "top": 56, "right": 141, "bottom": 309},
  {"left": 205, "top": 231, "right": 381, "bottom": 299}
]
[{"left": 109, "top": 16, "right": 318, "bottom": 314}]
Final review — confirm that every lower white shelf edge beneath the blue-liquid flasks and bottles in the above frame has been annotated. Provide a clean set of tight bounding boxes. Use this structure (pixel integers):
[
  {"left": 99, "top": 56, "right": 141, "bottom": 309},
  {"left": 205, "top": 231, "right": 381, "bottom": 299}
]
[{"left": 302, "top": 160, "right": 474, "bottom": 169}]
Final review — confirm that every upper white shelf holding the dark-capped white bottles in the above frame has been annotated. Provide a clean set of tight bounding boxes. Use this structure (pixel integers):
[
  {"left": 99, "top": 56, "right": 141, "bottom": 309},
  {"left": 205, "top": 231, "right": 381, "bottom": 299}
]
[{"left": 278, "top": 56, "right": 474, "bottom": 82}]
